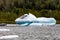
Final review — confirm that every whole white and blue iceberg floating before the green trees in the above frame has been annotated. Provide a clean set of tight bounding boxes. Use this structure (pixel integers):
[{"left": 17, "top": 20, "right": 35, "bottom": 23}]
[{"left": 15, "top": 13, "right": 56, "bottom": 26}]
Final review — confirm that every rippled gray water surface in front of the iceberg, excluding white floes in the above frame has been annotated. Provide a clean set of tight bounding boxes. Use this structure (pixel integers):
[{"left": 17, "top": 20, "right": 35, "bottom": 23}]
[{"left": 0, "top": 24, "right": 60, "bottom": 40}]
